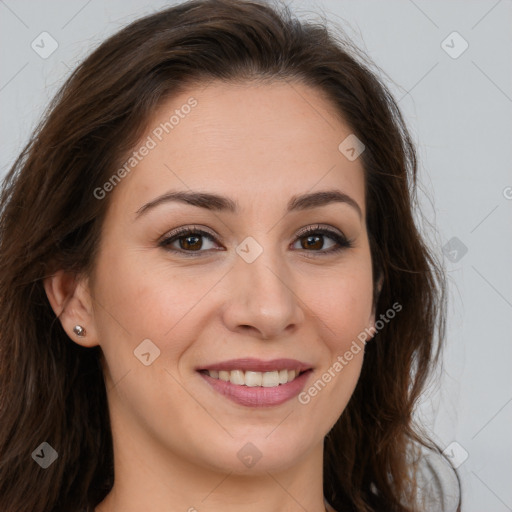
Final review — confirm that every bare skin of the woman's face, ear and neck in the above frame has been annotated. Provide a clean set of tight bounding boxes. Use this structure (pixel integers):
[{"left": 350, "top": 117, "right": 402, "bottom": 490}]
[{"left": 45, "top": 82, "right": 374, "bottom": 512}]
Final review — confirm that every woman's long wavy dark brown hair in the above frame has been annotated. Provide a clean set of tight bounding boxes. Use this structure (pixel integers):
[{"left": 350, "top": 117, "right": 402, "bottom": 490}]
[{"left": 0, "top": 0, "right": 460, "bottom": 512}]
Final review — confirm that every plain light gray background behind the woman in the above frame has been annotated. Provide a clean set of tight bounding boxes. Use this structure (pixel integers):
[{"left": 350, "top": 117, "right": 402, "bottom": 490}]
[{"left": 0, "top": 0, "right": 512, "bottom": 512}]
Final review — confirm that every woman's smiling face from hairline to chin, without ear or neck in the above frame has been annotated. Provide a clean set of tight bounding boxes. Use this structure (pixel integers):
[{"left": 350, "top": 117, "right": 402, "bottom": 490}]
[{"left": 86, "top": 82, "right": 373, "bottom": 473}]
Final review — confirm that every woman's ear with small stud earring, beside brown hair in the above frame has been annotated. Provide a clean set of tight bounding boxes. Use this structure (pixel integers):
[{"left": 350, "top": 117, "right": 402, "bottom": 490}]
[{"left": 44, "top": 270, "right": 98, "bottom": 347}]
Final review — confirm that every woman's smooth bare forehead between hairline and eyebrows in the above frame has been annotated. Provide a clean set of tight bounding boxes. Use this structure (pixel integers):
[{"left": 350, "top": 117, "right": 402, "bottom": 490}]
[{"left": 109, "top": 81, "right": 364, "bottom": 218}]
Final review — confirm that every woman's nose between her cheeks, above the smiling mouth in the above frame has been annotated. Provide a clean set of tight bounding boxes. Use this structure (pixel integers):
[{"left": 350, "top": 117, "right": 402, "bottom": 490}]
[{"left": 223, "top": 244, "right": 304, "bottom": 340}]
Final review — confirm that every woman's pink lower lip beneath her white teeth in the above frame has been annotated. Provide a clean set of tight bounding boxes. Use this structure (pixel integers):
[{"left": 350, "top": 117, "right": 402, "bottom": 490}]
[{"left": 199, "top": 370, "right": 312, "bottom": 407}]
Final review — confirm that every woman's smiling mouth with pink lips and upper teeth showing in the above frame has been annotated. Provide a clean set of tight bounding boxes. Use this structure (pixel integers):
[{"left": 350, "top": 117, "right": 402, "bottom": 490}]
[{"left": 197, "top": 359, "right": 313, "bottom": 407}]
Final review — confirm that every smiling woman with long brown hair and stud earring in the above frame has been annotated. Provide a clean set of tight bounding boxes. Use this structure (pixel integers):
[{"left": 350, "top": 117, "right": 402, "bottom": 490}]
[{"left": 0, "top": 0, "right": 460, "bottom": 512}]
